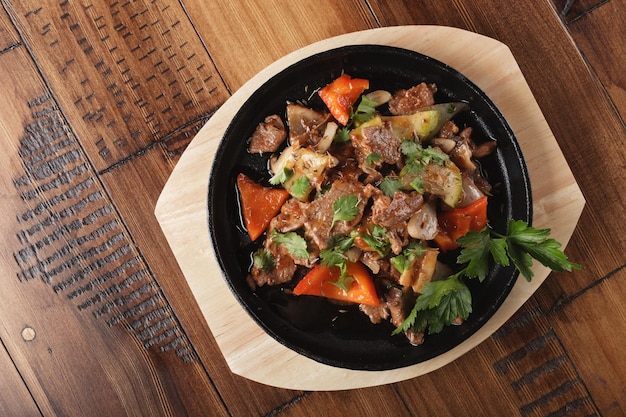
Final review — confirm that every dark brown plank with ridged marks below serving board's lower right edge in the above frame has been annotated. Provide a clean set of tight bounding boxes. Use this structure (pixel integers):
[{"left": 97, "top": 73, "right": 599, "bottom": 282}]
[{"left": 398, "top": 299, "right": 597, "bottom": 416}]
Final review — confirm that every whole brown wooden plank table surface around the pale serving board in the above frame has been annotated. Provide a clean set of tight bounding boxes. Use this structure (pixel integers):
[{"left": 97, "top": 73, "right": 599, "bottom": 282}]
[{"left": 0, "top": 0, "right": 626, "bottom": 416}]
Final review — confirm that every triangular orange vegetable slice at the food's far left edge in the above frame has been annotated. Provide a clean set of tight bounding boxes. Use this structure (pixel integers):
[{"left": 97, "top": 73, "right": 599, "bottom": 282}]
[{"left": 237, "top": 174, "right": 289, "bottom": 240}]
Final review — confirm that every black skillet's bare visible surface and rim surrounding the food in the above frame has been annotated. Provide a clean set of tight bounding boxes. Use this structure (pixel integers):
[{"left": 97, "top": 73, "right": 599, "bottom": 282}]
[{"left": 207, "top": 45, "right": 532, "bottom": 370}]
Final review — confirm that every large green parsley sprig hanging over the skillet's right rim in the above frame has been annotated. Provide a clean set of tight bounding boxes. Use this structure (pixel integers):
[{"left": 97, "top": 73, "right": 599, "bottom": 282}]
[{"left": 393, "top": 220, "right": 582, "bottom": 334}]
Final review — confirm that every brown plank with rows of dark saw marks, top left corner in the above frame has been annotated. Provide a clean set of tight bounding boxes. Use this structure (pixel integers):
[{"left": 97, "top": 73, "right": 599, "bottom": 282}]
[{"left": 10, "top": 0, "right": 228, "bottom": 171}]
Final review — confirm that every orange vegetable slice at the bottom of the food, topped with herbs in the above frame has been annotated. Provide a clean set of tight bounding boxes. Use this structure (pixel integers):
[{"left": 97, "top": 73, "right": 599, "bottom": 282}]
[{"left": 293, "top": 261, "right": 380, "bottom": 306}]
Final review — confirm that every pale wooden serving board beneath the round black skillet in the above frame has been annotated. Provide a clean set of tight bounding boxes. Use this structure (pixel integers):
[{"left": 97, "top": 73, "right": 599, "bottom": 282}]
[{"left": 155, "top": 26, "right": 585, "bottom": 390}]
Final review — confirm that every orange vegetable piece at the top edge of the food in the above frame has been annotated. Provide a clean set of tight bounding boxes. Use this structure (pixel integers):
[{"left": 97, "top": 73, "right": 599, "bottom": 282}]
[{"left": 318, "top": 74, "right": 370, "bottom": 126}]
